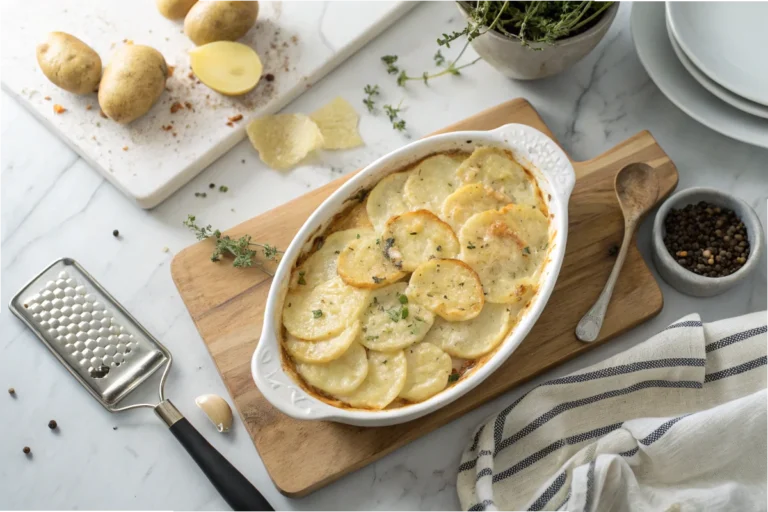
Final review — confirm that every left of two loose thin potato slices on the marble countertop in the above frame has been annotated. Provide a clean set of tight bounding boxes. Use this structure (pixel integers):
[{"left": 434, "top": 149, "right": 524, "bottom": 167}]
[{"left": 247, "top": 114, "right": 323, "bottom": 169}]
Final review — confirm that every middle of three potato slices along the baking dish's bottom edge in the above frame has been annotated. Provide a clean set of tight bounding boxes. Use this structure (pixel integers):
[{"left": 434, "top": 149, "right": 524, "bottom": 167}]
[{"left": 337, "top": 350, "right": 407, "bottom": 410}]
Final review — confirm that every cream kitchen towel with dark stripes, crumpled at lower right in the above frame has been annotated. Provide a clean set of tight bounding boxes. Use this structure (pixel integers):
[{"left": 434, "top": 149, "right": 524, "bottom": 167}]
[{"left": 457, "top": 312, "right": 768, "bottom": 512}]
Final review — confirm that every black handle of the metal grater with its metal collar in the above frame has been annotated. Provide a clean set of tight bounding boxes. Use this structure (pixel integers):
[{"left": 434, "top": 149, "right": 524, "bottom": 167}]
[{"left": 155, "top": 400, "right": 275, "bottom": 512}]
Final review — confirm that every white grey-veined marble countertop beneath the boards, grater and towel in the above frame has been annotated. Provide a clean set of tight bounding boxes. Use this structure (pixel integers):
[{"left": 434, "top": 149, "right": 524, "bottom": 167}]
[{"left": 0, "top": 0, "right": 768, "bottom": 512}]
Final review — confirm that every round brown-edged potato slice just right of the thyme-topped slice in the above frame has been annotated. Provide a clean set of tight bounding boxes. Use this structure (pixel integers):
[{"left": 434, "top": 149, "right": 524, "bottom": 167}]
[{"left": 407, "top": 259, "right": 485, "bottom": 322}]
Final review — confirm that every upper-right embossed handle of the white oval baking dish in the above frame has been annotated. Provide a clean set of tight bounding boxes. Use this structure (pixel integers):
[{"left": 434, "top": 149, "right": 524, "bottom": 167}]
[{"left": 491, "top": 123, "right": 576, "bottom": 205}]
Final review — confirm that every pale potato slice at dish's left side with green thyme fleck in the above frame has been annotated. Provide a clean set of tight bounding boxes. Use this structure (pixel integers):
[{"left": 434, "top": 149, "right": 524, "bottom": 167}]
[{"left": 283, "top": 277, "right": 370, "bottom": 340}]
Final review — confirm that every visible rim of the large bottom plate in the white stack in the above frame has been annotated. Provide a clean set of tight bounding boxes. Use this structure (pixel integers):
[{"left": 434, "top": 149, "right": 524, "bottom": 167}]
[{"left": 631, "top": 0, "right": 768, "bottom": 148}]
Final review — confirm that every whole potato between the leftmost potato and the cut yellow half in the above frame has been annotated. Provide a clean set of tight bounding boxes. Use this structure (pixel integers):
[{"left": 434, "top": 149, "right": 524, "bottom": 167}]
[{"left": 99, "top": 44, "right": 168, "bottom": 124}]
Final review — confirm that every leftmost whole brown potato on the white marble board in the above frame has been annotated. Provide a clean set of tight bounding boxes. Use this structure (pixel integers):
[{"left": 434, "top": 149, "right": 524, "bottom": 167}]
[{"left": 37, "top": 32, "right": 101, "bottom": 94}]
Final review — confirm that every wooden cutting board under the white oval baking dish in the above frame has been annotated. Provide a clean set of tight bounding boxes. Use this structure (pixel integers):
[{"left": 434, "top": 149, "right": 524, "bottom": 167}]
[{"left": 171, "top": 99, "right": 677, "bottom": 497}]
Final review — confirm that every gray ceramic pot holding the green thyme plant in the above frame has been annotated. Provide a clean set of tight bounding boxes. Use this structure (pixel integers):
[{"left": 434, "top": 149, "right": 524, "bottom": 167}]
[{"left": 456, "top": 2, "right": 619, "bottom": 80}]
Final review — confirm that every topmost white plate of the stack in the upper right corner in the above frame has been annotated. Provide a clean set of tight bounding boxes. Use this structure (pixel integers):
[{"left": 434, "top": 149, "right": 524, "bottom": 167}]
[{"left": 664, "top": 0, "right": 768, "bottom": 105}]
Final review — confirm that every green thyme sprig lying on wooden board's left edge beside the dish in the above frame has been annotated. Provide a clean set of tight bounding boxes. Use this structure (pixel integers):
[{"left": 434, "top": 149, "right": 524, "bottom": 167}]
[{"left": 184, "top": 215, "right": 283, "bottom": 275}]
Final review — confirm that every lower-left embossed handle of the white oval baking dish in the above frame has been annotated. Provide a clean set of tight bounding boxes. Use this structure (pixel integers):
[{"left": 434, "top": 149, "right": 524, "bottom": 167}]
[{"left": 251, "top": 336, "right": 328, "bottom": 420}]
